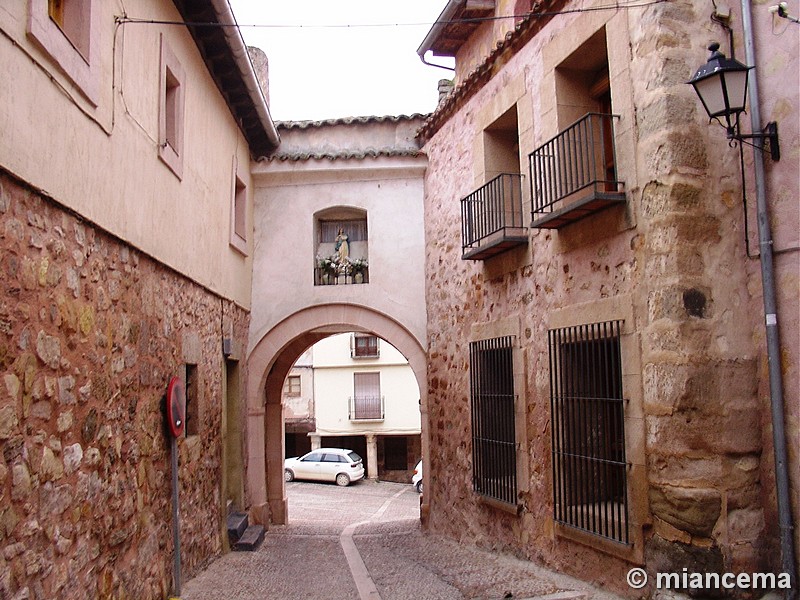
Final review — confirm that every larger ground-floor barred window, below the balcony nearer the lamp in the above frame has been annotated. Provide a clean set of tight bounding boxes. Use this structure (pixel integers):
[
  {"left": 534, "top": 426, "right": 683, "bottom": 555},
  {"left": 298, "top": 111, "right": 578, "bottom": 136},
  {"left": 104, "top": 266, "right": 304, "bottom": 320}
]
[{"left": 548, "top": 321, "right": 628, "bottom": 544}]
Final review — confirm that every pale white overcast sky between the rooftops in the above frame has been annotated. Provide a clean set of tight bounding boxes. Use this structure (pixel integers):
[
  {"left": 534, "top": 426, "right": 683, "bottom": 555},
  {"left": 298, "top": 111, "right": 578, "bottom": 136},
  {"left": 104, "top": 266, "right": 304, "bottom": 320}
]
[{"left": 230, "top": 0, "right": 453, "bottom": 121}]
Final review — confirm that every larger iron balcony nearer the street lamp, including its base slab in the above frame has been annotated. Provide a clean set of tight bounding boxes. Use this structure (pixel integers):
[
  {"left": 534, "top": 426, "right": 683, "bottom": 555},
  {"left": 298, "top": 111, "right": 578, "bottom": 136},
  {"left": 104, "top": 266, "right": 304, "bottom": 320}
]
[{"left": 528, "top": 113, "right": 625, "bottom": 229}]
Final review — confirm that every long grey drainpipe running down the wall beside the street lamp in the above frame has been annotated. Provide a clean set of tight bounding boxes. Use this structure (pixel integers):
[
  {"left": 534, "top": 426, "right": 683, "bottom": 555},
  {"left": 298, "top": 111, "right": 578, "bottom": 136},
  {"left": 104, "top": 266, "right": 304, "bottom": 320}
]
[{"left": 742, "top": 0, "right": 797, "bottom": 600}]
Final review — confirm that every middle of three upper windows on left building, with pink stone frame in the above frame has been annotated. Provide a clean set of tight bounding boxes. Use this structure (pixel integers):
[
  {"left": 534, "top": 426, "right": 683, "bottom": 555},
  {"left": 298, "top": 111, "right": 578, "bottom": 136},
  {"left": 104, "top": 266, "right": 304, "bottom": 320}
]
[{"left": 158, "top": 34, "right": 186, "bottom": 179}]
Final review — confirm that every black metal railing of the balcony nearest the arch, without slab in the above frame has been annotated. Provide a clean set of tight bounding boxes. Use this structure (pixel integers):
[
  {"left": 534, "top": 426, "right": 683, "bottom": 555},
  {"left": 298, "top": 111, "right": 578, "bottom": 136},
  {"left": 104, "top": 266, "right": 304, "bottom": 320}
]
[{"left": 461, "top": 173, "right": 526, "bottom": 254}]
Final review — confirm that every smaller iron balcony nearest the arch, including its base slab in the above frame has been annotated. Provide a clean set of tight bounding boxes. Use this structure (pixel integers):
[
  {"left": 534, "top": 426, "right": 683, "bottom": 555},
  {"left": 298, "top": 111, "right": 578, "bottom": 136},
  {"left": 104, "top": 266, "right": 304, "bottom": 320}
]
[{"left": 461, "top": 173, "right": 528, "bottom": 260}]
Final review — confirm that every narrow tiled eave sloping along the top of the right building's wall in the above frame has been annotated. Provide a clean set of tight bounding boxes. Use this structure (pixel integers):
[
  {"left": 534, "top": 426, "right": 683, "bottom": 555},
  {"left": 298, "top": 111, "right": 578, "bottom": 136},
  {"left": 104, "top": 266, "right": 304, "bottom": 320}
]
[{"left": 417, "top": 0, "right": 566, "bottom": 144}]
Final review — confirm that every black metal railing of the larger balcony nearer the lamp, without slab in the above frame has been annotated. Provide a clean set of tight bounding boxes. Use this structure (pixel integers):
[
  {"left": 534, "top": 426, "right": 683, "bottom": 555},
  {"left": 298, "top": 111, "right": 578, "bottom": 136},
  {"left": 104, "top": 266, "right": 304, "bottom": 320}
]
[{"left": 528, "top": 113, "right": 622, "bottom": 222}]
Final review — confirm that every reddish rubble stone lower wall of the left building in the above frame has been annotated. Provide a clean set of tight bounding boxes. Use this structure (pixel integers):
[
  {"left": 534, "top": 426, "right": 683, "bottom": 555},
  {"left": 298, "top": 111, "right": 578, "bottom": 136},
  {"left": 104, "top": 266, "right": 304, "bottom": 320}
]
[{"left": 0, "top": 173, "right": 248, "bottom": 600}]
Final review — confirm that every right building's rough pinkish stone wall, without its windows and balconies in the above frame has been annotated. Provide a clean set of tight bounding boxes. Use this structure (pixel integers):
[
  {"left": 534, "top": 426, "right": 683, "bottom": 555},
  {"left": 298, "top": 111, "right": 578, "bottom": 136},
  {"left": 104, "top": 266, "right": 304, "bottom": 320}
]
[{"left": 423, "top": 4, "right": 796, "bottom": 593}]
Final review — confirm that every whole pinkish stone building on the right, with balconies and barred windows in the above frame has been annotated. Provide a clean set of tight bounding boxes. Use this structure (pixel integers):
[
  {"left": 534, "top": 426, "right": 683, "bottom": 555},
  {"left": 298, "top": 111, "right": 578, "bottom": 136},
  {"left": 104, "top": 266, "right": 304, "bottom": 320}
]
[{"left": 418, "top": 0, "right": 800, "bottom": 595}]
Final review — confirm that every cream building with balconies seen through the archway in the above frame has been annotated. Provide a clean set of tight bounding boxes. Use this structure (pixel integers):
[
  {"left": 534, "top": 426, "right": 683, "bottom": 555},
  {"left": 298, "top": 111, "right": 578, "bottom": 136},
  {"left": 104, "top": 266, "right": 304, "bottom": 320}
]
[{"left": 284, "top": 333, "right": 422, "bottom": 483}]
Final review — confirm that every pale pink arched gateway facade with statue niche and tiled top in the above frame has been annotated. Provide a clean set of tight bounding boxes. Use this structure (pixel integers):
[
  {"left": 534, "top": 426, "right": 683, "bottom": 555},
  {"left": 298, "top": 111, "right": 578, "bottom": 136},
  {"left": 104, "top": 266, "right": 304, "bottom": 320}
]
[{"left": 247, "top": 115, "right": 427, "bottom": 523}]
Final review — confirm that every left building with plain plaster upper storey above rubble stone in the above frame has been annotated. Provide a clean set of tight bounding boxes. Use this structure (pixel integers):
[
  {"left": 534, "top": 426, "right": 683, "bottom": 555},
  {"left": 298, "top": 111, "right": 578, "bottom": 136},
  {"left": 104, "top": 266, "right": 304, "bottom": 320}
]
[{"left": 0, "top": 0, "right": 279, "bottom": 600}]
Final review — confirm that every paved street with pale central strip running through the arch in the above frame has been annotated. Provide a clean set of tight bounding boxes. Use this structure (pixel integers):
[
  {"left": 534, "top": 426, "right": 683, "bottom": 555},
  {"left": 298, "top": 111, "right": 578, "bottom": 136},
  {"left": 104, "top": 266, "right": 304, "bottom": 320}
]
[{"left": 181, "top": 481, "right": 617, "bottom": 600}]
